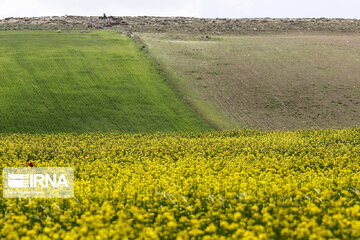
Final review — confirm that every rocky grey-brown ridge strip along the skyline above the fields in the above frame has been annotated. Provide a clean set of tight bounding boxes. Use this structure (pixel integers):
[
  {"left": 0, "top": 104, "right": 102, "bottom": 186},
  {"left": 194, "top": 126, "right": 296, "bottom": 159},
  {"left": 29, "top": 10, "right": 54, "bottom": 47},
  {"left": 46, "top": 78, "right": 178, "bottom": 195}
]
[{"left": 0, "top": 15, "right": 360, "bottom": 35}]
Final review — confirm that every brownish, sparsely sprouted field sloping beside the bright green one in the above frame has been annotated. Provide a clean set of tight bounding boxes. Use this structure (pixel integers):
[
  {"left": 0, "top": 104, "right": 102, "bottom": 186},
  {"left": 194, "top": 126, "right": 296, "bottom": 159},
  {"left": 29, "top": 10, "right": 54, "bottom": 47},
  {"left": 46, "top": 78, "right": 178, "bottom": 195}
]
[{"left": 140, "top": 33, "right": 360, "bottom": 129}]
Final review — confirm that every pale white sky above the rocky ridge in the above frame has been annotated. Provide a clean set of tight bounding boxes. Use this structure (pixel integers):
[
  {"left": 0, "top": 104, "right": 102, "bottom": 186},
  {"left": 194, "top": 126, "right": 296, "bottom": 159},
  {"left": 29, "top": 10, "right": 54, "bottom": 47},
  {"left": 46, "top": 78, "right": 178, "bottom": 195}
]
[{"left": 0, "top": 0, "right": 360, "bottom": 19}]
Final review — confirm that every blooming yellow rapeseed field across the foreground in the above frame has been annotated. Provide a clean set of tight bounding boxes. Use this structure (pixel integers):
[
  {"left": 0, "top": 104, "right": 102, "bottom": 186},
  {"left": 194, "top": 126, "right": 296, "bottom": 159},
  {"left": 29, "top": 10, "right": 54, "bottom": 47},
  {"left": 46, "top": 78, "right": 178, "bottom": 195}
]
[{"left": 0, "top": 129, "right": 360, "bottom": 239}]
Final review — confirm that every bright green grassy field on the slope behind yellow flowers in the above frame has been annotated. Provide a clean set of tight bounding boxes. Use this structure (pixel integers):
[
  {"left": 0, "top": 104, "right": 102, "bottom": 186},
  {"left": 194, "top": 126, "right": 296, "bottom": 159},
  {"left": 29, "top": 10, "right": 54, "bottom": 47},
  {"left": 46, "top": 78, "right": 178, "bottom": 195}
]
[{"left": 0, "top": 31, "right": 208, "bottom": 133}]
